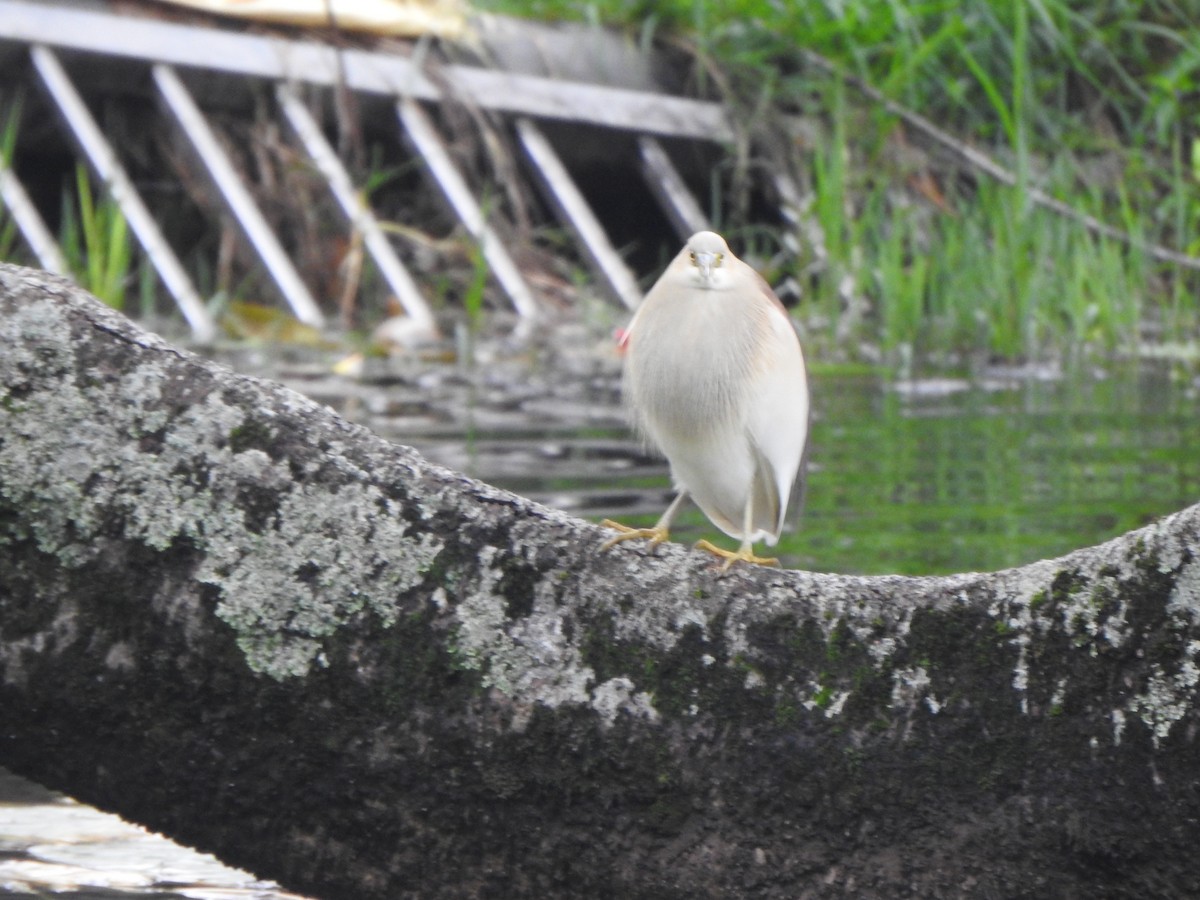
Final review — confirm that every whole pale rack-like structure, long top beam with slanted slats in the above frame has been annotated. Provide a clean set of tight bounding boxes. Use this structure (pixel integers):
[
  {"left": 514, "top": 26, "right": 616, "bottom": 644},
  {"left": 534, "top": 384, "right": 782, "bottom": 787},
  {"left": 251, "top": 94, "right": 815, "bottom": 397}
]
[{"left": 0, "top": 0, "right": 733, "bottom": 341}]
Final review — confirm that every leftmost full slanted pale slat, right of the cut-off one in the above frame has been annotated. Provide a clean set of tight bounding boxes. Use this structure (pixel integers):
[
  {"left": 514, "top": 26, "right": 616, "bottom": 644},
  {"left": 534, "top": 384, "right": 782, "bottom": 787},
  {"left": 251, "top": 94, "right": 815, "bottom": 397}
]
[{"left": 30, "top": 46, "right": 216, "bottom": 341}]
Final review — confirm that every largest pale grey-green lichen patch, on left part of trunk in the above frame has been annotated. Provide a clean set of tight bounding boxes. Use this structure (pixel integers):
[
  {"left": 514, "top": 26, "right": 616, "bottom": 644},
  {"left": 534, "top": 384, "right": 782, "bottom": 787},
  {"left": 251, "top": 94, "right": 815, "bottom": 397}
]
[{"left": 0, "top": 292, "right": 440, "bottom": 678}]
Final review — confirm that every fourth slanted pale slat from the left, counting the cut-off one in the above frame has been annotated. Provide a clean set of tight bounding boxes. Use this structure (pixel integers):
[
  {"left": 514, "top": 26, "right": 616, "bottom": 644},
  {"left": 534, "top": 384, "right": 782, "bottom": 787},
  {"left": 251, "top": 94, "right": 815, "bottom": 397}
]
[{"left": 275, "top": 83, "right": 434, "bottom": 326}]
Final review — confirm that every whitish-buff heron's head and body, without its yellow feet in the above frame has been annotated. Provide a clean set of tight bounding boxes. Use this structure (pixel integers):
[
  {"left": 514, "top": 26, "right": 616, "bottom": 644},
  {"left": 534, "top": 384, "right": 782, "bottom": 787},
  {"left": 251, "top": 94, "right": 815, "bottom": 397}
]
[{"left": 624, "top": 232, "right": 809, "bottom": 556}]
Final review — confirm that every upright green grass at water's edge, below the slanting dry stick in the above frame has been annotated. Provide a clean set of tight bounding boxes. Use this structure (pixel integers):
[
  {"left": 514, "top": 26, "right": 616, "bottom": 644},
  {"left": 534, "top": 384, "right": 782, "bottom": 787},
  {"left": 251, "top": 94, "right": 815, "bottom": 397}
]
[{"left": 805, "top": 91, "right": 1152, "bottom": 358}]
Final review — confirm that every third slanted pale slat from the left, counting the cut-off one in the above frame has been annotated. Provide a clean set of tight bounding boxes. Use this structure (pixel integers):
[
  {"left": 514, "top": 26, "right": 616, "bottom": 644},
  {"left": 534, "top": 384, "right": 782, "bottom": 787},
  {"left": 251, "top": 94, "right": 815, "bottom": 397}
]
[{"left": 151, "top": 62, "right": 325, "bottom": 328}]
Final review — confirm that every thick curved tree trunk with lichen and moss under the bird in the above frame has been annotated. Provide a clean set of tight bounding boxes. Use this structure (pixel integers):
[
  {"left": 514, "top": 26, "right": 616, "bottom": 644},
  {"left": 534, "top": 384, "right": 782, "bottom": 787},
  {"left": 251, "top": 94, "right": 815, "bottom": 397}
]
[{"left": 0, "top": 265, "right": 1200, "bottom": 900}]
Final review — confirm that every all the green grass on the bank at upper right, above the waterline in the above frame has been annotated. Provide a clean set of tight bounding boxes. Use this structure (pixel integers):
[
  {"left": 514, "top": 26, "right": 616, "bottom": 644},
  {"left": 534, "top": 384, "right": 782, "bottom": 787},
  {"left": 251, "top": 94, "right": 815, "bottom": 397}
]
[{"left": 478, "top": 0, "right": 1200, "bottom": 359}]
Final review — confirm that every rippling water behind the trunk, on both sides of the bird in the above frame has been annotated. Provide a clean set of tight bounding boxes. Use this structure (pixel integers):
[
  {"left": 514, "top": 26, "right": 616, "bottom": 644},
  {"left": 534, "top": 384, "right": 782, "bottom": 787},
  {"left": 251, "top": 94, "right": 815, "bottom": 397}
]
[{"left": 220, "top": 340, "right": 1200, "bottom": 574}]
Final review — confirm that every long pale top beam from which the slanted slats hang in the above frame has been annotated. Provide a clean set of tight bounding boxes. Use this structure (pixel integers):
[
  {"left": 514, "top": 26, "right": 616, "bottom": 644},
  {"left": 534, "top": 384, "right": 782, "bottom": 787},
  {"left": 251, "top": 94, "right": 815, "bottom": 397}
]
[{"left": 0, "top": 0, "right": 733, "bottom": 142}]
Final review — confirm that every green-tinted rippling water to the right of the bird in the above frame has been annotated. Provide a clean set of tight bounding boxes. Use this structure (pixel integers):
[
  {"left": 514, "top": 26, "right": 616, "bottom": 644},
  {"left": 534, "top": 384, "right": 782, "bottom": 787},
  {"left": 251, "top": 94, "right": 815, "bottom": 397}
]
[{"left": 787, "top": 365, "right": 1200, "bottom": 574}]
